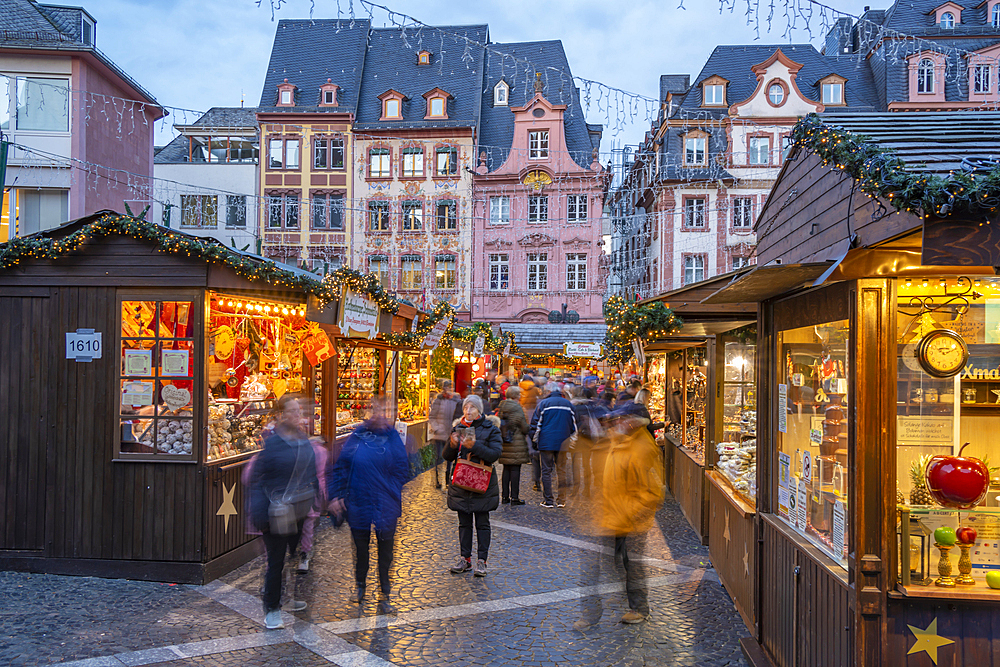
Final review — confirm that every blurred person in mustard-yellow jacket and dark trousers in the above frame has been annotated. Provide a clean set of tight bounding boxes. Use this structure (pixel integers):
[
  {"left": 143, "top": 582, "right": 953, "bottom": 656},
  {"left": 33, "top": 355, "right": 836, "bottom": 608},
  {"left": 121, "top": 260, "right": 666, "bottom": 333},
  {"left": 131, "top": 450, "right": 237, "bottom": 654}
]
[{"left": 573, "top": 412, "right": 665, "bottom": 631}]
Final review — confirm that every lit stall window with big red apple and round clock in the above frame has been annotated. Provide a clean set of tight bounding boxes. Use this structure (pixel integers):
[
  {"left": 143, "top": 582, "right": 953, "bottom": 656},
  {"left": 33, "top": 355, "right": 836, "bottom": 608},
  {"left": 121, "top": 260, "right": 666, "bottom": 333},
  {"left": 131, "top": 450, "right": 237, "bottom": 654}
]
[{"left": 896, "top": 277, "right": 1000, "bottom": 589}]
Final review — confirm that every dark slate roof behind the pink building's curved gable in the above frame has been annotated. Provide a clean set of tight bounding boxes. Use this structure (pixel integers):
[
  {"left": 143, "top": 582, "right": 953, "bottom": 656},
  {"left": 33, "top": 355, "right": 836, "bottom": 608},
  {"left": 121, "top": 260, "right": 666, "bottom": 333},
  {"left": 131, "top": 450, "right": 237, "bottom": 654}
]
[{"left": 477, "top": 40, "right": 594, "bottom": 171}]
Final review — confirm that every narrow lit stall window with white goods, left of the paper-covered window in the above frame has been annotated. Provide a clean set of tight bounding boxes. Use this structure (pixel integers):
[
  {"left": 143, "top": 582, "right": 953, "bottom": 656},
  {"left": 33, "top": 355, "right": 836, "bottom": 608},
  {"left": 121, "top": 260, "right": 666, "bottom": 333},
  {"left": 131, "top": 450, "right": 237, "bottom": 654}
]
[{"left": 716, "top": 337, "right": 757, "bottom": 503}]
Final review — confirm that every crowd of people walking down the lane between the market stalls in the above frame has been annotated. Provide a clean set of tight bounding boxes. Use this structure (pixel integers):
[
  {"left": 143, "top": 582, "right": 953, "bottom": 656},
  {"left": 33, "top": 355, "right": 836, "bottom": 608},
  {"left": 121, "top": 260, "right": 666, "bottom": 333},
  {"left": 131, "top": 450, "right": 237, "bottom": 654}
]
[{"left": 244, "top": 370, "right": 665, "bottom": 631}]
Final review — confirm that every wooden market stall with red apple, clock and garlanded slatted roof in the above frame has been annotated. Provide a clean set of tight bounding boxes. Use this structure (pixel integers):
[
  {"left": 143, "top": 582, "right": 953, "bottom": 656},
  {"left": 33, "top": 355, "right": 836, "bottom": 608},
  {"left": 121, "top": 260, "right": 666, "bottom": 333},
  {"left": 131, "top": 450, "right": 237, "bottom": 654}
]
[{"left": 706, "top": 113, "right": 1000, "bottom": 667}]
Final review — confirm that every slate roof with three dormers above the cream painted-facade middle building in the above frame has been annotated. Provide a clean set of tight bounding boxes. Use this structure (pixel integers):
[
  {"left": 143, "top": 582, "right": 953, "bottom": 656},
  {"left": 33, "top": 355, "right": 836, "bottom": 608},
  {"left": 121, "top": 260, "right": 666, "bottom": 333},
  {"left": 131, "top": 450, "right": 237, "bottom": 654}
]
[{"left": 354, "top": 25, "right": 489, "bottom": 130}]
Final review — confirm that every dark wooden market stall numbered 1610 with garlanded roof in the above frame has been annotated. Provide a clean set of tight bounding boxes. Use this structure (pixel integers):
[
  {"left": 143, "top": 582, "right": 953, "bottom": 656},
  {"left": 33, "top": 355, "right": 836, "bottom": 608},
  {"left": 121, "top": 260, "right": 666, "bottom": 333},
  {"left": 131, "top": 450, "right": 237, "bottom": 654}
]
[{"left": 0, "top": 211, "right": 352, "bottom": 583}]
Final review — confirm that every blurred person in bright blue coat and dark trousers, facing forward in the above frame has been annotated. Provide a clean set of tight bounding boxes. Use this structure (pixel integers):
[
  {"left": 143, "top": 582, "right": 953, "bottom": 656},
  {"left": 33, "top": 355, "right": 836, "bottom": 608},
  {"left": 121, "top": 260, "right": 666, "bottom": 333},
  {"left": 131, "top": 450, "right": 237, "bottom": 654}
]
[{"left": 326, "top": 399, "right": 410, "bottom": 604}]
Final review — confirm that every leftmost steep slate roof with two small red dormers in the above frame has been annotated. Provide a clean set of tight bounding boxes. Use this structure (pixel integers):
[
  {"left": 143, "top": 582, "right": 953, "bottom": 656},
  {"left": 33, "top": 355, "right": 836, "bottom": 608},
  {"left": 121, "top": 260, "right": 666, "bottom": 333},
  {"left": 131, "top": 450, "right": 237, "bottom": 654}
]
[{"left": 259, "top": 19, "right": 371, "bottom": 113}]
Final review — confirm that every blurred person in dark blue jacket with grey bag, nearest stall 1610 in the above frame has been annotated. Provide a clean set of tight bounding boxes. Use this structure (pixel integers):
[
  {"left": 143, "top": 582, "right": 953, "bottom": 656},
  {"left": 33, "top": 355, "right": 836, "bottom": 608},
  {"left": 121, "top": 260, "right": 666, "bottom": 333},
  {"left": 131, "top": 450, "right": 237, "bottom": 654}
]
[{"left": 250, "top": 394, "right": 320, "bottom": 630}]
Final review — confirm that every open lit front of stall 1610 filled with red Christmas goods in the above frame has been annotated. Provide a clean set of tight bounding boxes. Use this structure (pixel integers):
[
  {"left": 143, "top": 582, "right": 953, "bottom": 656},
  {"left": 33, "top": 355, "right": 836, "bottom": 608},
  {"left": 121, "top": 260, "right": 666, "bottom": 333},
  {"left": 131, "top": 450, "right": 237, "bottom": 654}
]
[{"left": 206, "top": 293, "right": 310, "bottom": 461}]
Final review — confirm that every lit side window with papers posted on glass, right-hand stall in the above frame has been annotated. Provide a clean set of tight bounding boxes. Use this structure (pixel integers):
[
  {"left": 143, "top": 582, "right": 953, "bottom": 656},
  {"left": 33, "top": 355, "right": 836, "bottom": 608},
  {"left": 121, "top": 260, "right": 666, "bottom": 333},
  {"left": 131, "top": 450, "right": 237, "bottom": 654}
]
[{"left": 775, "top": 320, "right": 851, "bottom": 568}]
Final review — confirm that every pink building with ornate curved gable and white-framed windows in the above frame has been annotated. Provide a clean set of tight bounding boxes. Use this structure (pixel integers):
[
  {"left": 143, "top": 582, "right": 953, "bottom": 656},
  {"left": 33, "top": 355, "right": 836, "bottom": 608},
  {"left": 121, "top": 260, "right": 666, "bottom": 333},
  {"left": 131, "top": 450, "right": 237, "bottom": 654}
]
[{"left": 472, "top": 79, "right": 607, "bottom": 324}]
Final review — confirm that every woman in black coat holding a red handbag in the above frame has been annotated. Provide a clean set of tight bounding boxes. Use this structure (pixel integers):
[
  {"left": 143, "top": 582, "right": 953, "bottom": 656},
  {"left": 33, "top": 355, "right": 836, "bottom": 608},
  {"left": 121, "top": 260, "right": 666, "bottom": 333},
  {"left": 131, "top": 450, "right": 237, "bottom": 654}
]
[{"left": 444, "top": 394, "right": 503, "bottom": 577}]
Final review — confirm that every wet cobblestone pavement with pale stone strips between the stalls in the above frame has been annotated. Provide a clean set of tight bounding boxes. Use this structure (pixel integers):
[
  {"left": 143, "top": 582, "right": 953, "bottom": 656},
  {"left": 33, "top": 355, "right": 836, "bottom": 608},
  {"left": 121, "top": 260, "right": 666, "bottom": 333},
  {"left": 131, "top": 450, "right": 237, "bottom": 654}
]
[{"left": 0, "top": 473, "right": 748, "bottom": 667}]
